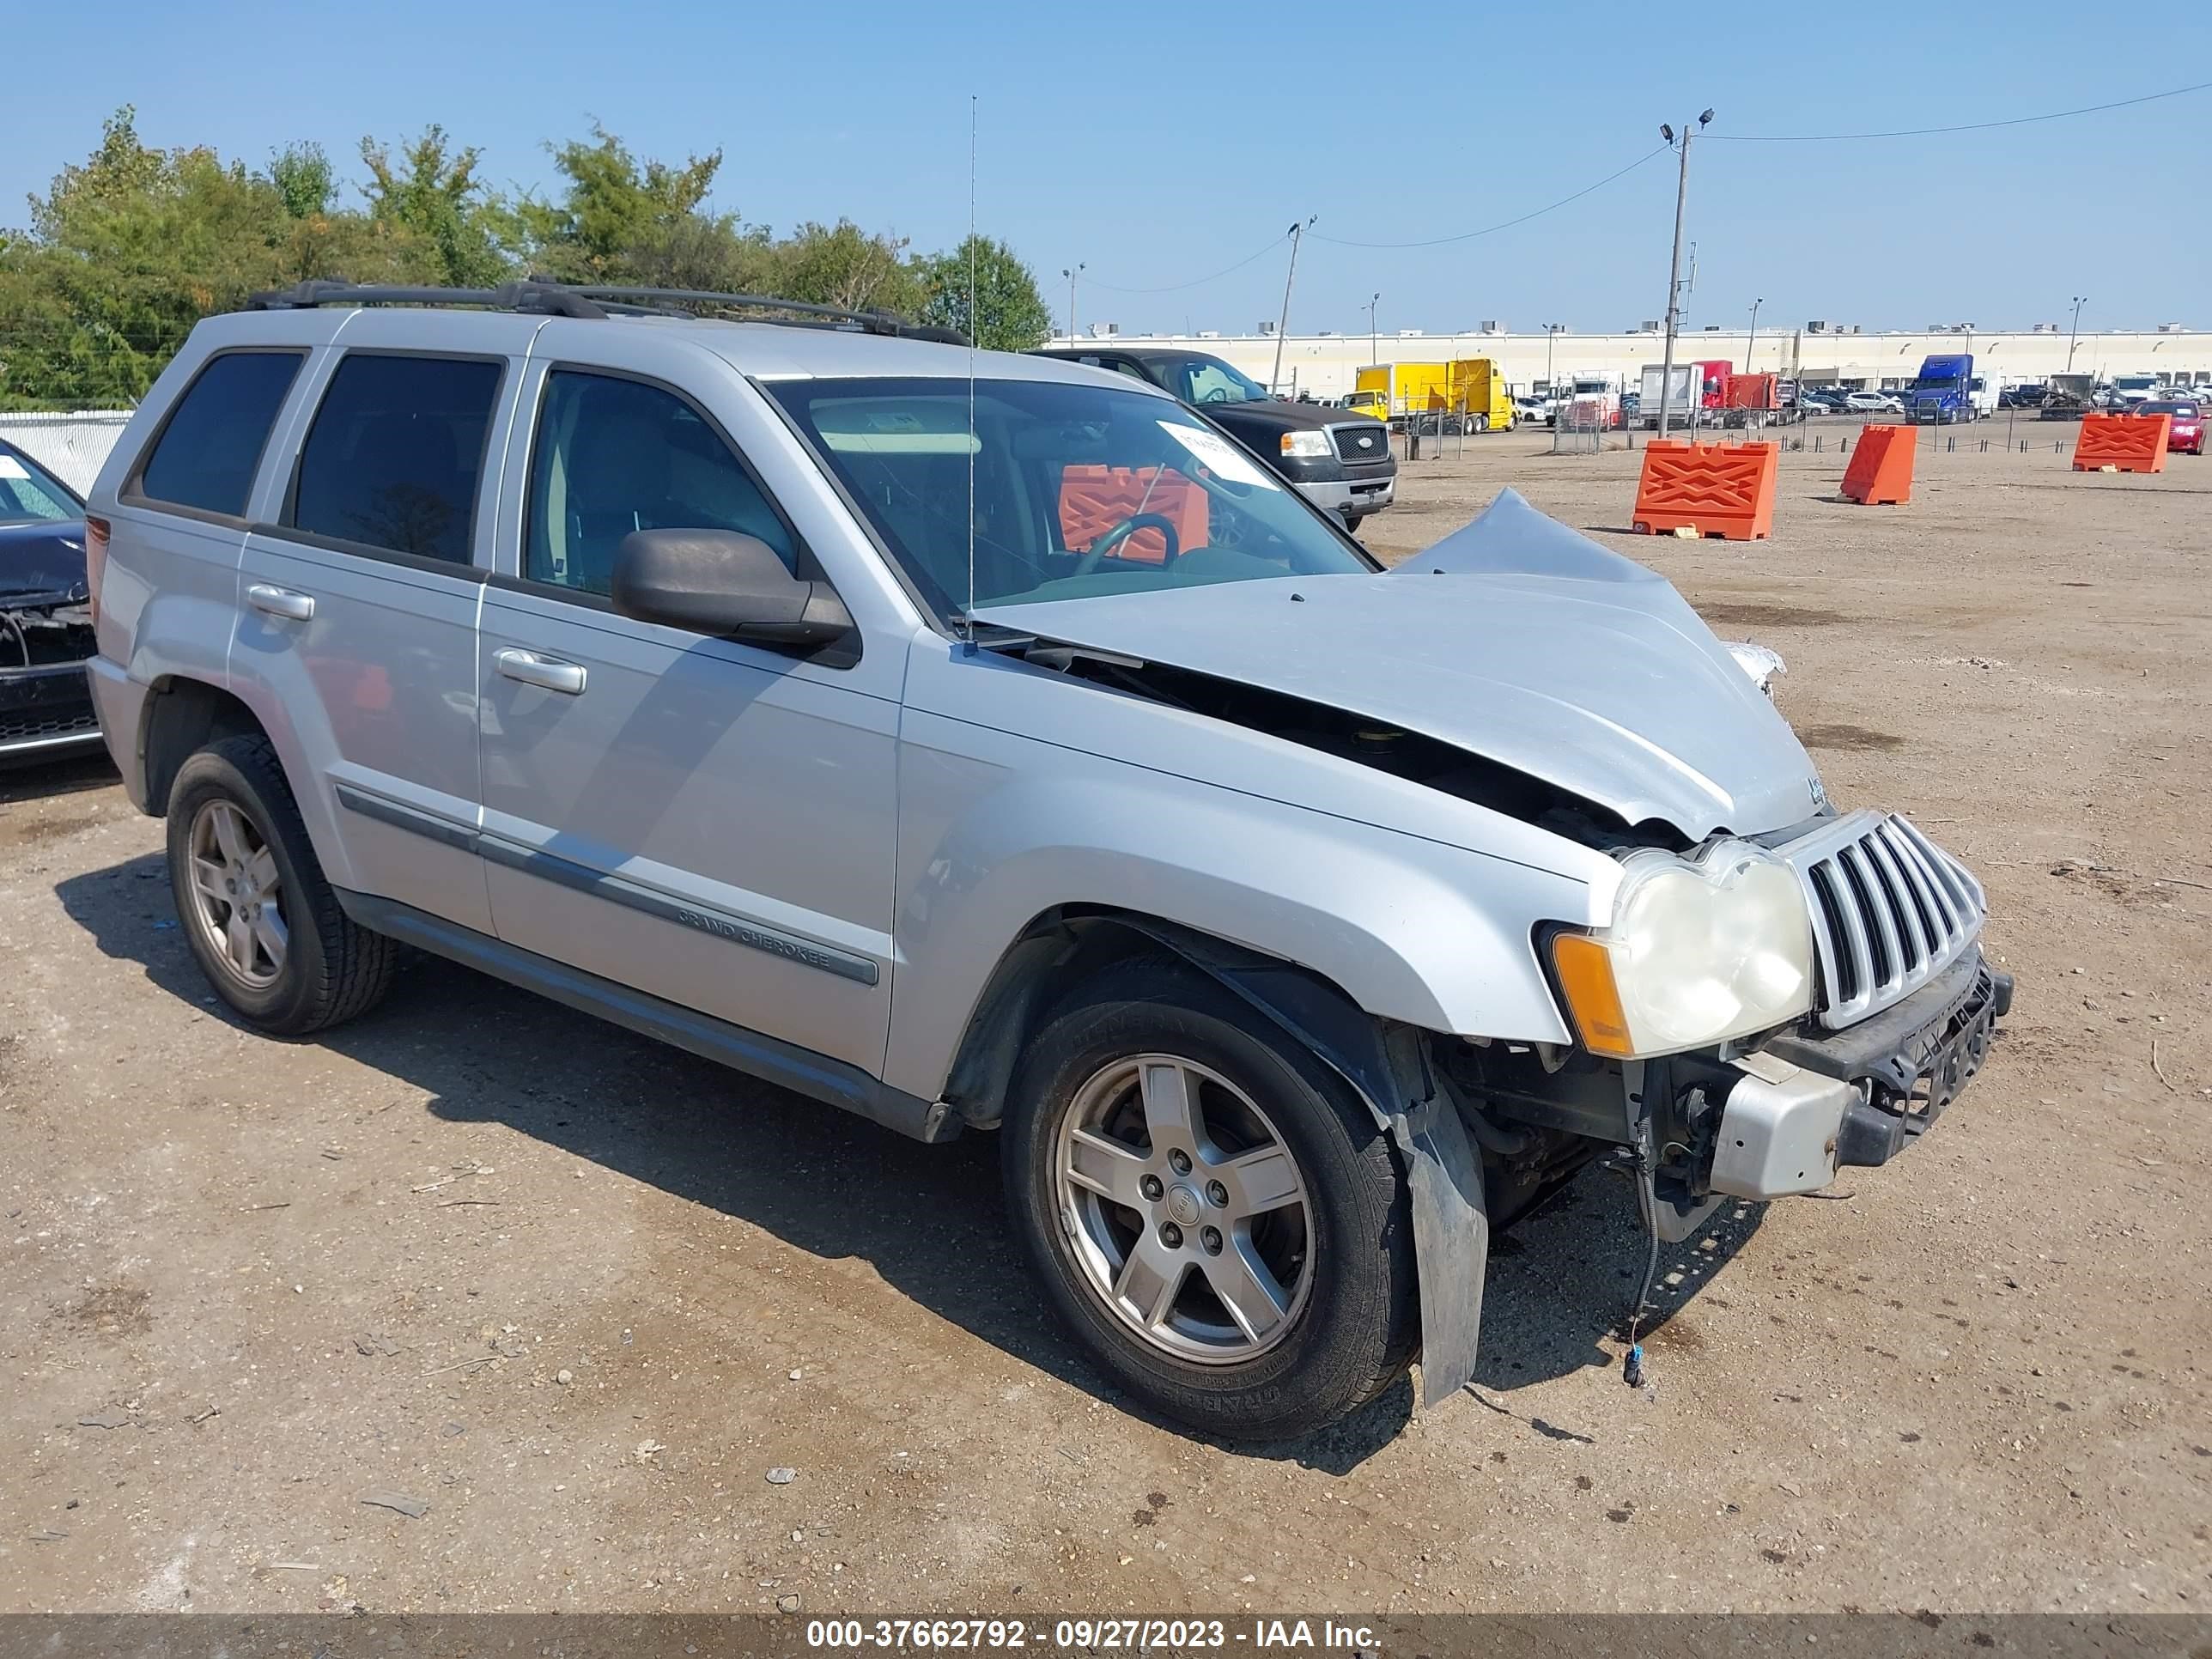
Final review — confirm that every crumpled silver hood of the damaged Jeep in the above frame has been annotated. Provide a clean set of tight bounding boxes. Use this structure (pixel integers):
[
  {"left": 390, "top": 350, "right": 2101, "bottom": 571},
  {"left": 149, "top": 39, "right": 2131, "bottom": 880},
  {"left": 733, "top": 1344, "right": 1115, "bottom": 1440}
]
[{"left": 978, "top": 491, "right": 1820, "bottom": 841}]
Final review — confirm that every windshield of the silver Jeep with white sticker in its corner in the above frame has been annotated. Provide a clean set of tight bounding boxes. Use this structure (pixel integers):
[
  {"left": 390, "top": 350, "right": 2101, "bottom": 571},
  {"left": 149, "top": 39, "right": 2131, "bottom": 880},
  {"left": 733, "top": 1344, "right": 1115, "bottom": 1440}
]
[{"left": 768, "top": 378, "right": 1374, "bottom": 615}]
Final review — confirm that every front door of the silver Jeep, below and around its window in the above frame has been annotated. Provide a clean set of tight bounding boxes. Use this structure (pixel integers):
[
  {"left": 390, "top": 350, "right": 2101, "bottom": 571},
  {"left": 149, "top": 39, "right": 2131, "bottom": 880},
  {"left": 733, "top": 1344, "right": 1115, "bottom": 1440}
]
[{"left": 480, "top": 358, "right": 898, "bottom": 1075}]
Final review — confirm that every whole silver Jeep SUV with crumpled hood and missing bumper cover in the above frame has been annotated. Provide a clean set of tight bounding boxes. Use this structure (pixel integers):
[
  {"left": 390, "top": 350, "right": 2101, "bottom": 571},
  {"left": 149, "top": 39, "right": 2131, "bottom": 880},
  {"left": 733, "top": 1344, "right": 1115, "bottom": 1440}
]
[{"left": 88, "top": 285, "right": 2011, "bottom": 1437}]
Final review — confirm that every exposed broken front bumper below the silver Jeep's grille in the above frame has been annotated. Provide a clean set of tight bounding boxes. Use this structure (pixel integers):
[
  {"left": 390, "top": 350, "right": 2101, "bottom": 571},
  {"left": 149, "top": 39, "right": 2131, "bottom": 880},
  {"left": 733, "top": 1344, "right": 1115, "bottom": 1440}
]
[{"left": 1708, "top": 949, "right": 2013, "bottom": 1199}]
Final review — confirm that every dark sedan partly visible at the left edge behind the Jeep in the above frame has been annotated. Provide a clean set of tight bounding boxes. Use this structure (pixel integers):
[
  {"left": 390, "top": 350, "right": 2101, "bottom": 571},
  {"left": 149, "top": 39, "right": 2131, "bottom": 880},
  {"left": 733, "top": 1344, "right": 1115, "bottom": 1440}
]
[{"left": 0, "top": 441, "right": 100, "bottom": 765}]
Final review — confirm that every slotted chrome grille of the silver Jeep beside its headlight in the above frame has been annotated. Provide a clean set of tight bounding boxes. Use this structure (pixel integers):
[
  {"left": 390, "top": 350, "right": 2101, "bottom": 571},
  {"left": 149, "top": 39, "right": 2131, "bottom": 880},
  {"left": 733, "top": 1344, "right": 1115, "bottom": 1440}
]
[{"left": 1777, "top": 811, "right": 1984, "bottom": 1030}]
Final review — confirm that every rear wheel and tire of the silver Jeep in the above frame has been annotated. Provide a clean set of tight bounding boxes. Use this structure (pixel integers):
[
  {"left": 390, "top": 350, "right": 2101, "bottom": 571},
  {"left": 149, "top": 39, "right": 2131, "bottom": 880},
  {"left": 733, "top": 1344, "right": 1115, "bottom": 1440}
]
[{"left": 168, "top": 737, "right": 398, "bottom": 1037}]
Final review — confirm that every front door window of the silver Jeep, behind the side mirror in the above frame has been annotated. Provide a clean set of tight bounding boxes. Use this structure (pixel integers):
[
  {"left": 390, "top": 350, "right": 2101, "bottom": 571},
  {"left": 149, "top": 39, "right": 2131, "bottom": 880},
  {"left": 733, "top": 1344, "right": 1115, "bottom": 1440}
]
[{"left": 522, "top": 369, "right": 796, "bottom": 592}]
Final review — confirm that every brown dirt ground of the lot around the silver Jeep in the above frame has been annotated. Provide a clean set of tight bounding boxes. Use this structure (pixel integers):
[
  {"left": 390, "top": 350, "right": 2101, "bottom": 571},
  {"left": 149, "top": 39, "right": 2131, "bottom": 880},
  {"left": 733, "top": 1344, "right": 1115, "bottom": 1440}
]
[{"left": 0, "top": 427, "right": 2212, "bottom": 1614}]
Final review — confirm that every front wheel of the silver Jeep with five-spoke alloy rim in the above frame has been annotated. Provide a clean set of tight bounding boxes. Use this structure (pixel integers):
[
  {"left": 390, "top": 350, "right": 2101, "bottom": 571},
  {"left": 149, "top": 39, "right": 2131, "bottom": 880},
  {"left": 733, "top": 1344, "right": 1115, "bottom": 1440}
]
[{"left": 1002, "top": 957, "right": 1418, "bottom": 1440}]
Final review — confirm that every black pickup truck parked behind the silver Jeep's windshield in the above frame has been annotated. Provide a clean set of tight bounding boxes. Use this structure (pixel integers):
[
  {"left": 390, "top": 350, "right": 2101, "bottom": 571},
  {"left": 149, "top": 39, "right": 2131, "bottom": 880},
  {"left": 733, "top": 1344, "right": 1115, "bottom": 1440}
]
[{"left": 1036, "top": 341, "right": 1398, "bottom": 525}]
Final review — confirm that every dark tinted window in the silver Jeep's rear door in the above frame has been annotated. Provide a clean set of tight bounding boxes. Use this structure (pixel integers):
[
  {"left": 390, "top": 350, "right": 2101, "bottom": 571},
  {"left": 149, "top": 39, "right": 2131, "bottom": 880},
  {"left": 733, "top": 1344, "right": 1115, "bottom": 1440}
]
[{"left": 288, "top": 354, "right": 504, "bottom": 564}]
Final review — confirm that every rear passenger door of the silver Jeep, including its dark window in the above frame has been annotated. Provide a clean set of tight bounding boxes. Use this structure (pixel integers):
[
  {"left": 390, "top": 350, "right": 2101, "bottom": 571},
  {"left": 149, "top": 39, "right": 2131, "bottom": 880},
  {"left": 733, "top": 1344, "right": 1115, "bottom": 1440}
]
[{"left": 232, "top": 312, "right": 533, "bottom": 931}]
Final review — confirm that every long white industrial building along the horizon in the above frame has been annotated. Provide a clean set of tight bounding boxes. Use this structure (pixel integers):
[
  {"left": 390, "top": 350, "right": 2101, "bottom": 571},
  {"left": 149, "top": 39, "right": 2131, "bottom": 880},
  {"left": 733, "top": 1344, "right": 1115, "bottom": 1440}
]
[{"left": 1053, "top": 323, "right": 2212, "bottom": 398}]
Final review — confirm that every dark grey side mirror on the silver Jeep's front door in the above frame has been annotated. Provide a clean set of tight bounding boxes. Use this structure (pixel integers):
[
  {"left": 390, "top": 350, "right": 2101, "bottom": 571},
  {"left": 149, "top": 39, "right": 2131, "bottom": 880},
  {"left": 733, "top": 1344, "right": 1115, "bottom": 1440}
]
[{"left": 611, "top": 531, "right": 852, "bottom": 646}]
